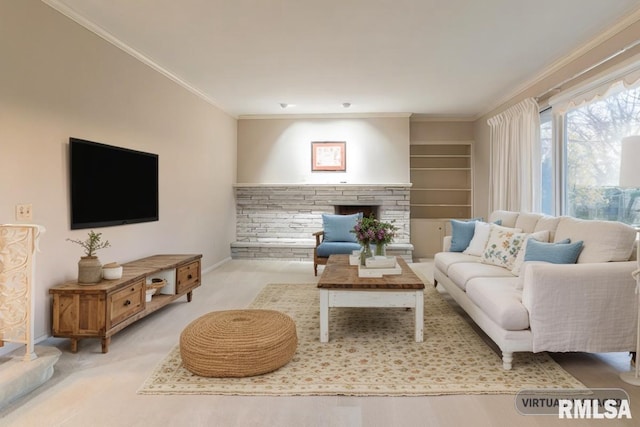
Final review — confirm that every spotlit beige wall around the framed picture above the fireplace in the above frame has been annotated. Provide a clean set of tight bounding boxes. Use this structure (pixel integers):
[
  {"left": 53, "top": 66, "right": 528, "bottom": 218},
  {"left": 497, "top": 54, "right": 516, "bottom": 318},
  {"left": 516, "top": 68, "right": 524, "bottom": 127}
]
[{"left": 238, "top": 117, "right": 409, "bottom": 184}]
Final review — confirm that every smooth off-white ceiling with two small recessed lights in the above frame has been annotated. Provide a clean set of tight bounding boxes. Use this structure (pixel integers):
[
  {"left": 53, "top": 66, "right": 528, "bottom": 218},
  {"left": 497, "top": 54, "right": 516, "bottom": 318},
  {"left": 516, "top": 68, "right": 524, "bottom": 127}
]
[{"left": 43, "top": 0, "right": 640, "bottom": 118}]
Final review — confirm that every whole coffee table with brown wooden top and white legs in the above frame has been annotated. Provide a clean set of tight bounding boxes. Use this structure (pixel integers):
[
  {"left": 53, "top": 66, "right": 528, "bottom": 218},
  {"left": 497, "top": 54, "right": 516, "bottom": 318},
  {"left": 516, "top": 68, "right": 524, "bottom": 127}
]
[{"left": 318, "top": 255, "right": 424, "bottom": 342}]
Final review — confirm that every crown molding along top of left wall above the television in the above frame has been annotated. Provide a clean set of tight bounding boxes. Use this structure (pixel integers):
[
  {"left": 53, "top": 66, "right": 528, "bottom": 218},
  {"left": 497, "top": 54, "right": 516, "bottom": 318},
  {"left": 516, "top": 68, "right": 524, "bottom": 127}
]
[{"left": 41, "top": 0, "right": 232, "bottom": 119}]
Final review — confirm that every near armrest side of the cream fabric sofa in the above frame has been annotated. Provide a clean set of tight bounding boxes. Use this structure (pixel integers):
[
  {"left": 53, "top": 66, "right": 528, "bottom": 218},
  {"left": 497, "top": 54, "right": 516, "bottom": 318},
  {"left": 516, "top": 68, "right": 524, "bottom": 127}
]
[{"left": 522, "top": 261, "right": 638, "bottom": 352}]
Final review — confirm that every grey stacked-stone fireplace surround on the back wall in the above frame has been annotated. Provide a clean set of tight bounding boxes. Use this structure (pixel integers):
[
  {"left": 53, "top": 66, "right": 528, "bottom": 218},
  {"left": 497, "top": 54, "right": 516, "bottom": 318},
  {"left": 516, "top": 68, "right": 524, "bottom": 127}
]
[{"left": 231, "top": 184, "right": 413, "bottom": 261}]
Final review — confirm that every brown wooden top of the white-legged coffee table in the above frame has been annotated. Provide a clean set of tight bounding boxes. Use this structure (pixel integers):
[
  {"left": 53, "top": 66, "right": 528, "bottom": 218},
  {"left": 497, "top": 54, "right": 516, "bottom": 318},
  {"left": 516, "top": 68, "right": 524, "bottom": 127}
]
[{"left": 318, "top": 255, "right": 424, "bottom": 290}]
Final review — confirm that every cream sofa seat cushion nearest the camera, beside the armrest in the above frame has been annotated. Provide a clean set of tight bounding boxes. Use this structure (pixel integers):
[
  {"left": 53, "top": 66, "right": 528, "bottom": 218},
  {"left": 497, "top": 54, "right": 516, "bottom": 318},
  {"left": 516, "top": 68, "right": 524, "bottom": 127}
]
[{"left": 467, "top": 276, "right": 529, "bottom": 331}]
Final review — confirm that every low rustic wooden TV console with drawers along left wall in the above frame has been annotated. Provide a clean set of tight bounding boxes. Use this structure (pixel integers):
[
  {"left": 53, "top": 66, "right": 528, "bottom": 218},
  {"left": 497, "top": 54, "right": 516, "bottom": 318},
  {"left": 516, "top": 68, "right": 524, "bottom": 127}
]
[{"left": 49, "top": 255, "right": 202, "bottom": 353}]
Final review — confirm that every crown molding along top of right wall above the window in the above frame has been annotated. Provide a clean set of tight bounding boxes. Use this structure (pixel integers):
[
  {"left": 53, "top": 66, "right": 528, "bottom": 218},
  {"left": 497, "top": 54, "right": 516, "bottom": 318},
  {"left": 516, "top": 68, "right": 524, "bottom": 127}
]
[{"left": 474, "top": 6, "right": 640, "bottom": 120}]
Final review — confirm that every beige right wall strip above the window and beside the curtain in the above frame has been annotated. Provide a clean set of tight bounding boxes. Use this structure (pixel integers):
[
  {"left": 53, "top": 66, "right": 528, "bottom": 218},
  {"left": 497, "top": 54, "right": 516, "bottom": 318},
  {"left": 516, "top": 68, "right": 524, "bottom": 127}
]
[{"left": 473, "top": 22, "right": 640, "bottom": 217}]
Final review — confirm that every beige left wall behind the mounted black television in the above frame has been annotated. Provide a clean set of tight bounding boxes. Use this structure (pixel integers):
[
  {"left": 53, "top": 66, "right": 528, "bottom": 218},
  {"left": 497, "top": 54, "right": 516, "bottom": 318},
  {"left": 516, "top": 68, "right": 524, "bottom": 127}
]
[{"left": 0, "top": 0, "right": 236, "bottom": 349}]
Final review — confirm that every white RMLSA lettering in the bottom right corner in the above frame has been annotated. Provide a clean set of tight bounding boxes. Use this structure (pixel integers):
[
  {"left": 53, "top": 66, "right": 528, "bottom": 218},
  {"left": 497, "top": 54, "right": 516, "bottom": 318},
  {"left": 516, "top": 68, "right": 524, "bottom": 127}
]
[{"left": 558, "top": 399, "right": 631, "bottom": 420}]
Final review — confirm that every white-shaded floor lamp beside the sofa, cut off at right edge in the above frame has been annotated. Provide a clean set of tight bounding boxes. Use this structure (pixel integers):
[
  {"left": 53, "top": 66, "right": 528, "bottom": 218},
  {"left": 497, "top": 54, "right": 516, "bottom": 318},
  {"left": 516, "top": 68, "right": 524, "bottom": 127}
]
[{"left": 620, "top": 135, "right": 640, "bottom": 385}]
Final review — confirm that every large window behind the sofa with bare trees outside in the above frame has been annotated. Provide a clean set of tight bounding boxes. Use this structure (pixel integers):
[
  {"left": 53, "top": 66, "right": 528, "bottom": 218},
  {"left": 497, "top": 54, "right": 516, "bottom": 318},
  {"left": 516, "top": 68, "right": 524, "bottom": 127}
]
[{"left": 560, "top": 85, "right": 640, "bottom": 224}]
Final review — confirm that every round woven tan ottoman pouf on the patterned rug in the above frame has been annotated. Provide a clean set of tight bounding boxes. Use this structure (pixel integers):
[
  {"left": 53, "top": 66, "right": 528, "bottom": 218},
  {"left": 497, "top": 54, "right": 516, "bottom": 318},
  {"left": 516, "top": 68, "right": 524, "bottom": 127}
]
[{"left": 180, "top": 310, "right": 298, "bottom": 377}]
